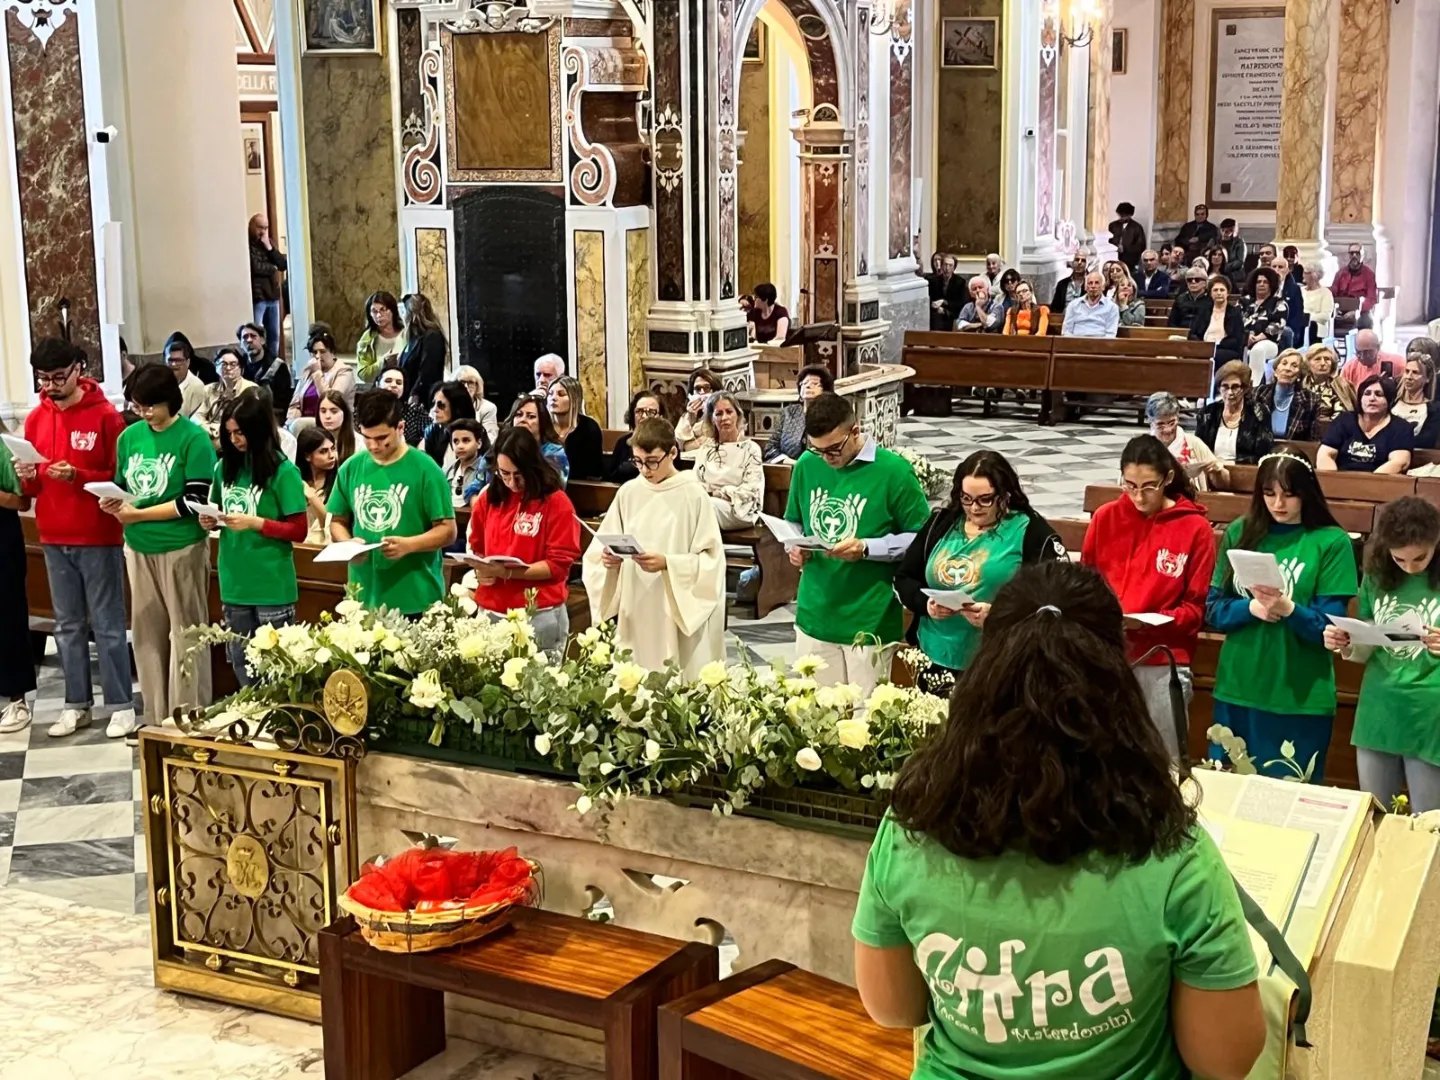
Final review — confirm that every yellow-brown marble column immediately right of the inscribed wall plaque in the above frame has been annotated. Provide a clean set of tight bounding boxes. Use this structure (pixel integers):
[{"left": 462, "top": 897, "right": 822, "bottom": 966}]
[{"left": 1274, "top": 0, "right": 1332, "bottom": 264}]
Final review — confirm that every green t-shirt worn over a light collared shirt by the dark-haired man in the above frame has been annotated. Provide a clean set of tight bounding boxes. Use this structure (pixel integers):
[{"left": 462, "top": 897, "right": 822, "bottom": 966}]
[{"left": 785, "top": 446, "right": 930, "bottom": 645}]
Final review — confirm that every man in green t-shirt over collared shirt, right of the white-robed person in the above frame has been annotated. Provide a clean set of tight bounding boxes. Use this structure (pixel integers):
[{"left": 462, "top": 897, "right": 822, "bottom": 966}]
[{"left": 785, "top": 393, "right": 930, "bottom": 696}]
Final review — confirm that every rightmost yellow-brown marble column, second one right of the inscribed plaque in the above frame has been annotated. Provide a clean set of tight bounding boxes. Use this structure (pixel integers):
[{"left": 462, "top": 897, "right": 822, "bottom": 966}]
[{"left": 1326, "top": 0, "right": 1394, "bottom": 260}]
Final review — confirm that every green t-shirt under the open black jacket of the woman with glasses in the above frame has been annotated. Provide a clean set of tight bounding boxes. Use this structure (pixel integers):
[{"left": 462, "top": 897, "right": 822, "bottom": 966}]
[{"left": 919, "top": 514, "right": 1030, "bottom": 671}]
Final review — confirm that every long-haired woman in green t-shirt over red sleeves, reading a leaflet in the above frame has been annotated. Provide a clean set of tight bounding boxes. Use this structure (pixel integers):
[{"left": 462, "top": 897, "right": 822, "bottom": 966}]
[{"left": 200, "top": 393, "right": 310, "bottom": 687}]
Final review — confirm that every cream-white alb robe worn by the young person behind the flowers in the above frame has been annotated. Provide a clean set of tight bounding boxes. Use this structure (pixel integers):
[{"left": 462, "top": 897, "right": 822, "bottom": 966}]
[{"left": 582, "top": 472, "right": 724, "bottom": 678}]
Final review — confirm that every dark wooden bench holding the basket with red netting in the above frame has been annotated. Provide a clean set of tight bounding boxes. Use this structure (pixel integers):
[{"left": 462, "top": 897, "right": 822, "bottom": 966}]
[{"left": 320, "top": 909, "right": 719, "bottom": 1080}]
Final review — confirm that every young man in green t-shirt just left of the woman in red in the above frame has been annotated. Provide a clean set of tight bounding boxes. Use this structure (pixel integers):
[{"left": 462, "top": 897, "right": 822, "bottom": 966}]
[{"left": 328, "top": 390, "right": 455, "bottom": 616}]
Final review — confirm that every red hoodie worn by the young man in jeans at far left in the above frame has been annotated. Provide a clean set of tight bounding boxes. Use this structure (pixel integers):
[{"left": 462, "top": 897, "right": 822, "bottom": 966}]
[{"left": 22, "top": 379, "right": 125, "bottom": 547}]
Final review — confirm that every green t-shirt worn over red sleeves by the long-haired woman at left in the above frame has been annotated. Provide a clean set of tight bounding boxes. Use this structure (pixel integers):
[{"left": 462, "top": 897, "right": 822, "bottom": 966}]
[{"left": 210, "top": 458, "right": 305, "bottom": 608}]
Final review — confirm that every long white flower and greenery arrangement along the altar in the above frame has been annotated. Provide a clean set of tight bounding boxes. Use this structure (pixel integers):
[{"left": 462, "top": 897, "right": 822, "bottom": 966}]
[{"left": 192, "top": 586, "right": 948, "bottom": 814}]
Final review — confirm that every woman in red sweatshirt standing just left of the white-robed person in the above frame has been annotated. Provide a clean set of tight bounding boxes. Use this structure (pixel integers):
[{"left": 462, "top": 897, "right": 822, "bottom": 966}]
[{"left": 469, "top": 426, "right": 580, "bottom": 654}]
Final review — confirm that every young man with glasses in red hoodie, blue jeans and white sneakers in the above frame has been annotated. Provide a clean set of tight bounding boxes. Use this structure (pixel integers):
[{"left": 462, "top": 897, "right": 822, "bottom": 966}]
[{"left": 15, "top": 337, "right": 135, "bottom": 739}]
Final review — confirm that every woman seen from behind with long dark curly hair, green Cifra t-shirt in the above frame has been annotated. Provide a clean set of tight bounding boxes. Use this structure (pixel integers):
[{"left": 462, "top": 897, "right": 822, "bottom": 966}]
[{"left": 852, "top": 562, "right": 1266, "bottom": 1077}]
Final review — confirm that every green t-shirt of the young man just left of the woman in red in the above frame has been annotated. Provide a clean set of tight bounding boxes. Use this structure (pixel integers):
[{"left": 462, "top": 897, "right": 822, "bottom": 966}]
[{"left": 327, "top": 446, "right": 455, "bottom": 615}]
